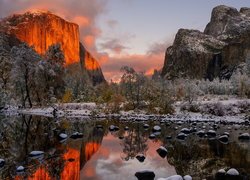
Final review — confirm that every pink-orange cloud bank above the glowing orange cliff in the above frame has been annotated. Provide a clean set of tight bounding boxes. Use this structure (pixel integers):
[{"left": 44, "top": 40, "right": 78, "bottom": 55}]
[{"left": 0, "top": 0, "right": 107, "bottom": 51}]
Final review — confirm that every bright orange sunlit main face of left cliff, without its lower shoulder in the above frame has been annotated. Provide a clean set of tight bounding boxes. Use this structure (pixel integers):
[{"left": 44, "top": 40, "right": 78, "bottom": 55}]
[{"left": 0, "top": 12, "right": 80, "bottom": 64}]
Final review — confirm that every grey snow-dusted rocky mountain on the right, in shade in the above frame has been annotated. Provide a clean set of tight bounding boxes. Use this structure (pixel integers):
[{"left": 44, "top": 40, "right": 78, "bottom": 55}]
[{"left": 162, "top": 5, "right": 250, "bottom": 80}]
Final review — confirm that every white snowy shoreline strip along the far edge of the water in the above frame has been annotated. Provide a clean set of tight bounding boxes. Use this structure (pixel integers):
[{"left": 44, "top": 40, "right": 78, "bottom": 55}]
[{"left": 1, "top": 99, "right": 250, "bottom": 123}]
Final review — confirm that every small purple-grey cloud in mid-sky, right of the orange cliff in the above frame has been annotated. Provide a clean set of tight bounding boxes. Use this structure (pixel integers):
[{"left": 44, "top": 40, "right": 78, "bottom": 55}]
[{"left": 100, "top": 38, "right": 128, "bottom": 54}]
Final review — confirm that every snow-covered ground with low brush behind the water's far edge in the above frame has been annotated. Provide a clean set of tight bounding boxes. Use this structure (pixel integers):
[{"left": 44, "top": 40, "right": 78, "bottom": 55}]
[{"left": 0, "top": 97, "right": 250, "bottom": 122}]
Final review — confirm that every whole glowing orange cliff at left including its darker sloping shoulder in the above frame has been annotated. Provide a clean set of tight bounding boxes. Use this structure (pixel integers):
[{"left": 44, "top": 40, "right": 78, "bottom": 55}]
[{"left": 0, "top": 11, "right": 105, "bottom": 84}]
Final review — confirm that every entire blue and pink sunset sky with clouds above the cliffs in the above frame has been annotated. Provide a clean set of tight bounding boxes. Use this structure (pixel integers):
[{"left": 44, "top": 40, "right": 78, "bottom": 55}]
[{"left": 0, "top": 0, "right": 250, "bottom": 81}]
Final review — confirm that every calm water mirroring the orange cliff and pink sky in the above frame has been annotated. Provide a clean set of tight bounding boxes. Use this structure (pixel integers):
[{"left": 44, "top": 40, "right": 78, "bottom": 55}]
[{"left": 0, "top": 116, "right": 250, "bottom": 180}]
